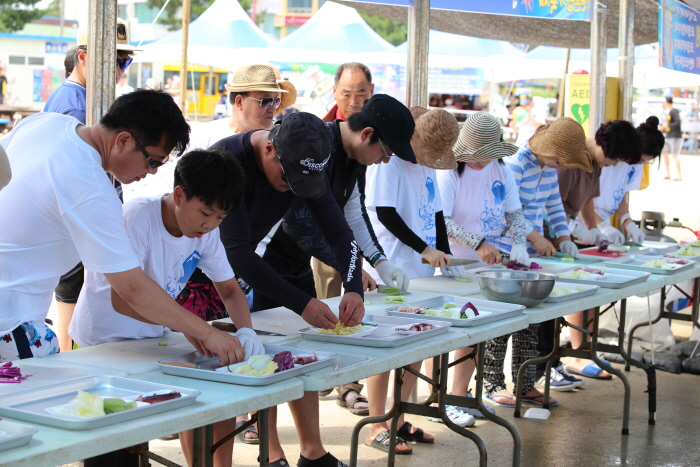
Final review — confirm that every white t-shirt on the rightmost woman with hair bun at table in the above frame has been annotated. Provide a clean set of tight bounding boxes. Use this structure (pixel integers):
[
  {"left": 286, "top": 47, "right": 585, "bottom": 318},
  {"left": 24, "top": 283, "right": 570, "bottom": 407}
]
[{"left": 593, "top": 161, "right": 644, "bottom": 220}]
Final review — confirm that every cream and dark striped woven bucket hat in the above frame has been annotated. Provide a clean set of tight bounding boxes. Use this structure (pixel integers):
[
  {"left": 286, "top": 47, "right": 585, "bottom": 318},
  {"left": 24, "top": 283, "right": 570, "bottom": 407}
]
[{"left": 454, "top": 112, "right": 518, "bottom": 162}]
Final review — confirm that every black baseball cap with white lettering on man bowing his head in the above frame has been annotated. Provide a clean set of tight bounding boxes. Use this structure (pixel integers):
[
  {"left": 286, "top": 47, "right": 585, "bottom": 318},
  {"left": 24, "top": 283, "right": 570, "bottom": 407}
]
[{"left": 270, "top": 112, "right": 331, "bottom": 198}]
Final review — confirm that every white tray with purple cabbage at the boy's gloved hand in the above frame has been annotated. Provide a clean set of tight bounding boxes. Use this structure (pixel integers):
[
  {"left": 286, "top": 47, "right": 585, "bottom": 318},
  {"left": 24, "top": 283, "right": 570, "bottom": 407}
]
[{"left": 158, "top": 345, "right": 337, "bottom": 386}]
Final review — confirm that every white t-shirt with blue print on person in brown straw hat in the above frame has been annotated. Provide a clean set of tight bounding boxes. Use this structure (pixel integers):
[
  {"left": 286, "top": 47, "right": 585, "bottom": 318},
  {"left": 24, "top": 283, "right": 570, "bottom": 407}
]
[{"left": 365, "top": 157, "right": 442, "bottom": 280}]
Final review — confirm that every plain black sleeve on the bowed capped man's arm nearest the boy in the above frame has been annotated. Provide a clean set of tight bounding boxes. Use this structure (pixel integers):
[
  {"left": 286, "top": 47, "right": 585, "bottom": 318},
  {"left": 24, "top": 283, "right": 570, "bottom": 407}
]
[{"left": 219, "top": 206, "right": 312, "bottom": 314}]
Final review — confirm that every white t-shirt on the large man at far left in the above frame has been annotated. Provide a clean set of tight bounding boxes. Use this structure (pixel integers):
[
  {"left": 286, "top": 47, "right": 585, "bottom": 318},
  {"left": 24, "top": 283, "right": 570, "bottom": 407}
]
[{"left": 0, "top": 112, "right": 139, "bottom": 335}]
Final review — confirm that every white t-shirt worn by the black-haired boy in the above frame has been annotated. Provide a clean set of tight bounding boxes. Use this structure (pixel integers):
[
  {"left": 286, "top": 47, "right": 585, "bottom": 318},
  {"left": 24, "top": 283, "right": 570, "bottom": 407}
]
[{"left": 69, "top": 195, "right": 233, "bottom": 347}]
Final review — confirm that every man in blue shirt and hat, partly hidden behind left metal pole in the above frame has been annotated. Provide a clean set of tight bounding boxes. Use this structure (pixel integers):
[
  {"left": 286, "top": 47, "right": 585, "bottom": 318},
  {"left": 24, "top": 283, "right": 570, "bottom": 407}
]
[{"left": 43, "top": 18, "right": 140, "bottom": 352}]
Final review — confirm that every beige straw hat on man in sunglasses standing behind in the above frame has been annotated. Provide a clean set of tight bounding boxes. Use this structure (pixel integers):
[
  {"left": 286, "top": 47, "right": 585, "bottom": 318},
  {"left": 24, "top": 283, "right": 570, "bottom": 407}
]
[{"left": 225, "top": 65, "right": 297, "bottom": 111}]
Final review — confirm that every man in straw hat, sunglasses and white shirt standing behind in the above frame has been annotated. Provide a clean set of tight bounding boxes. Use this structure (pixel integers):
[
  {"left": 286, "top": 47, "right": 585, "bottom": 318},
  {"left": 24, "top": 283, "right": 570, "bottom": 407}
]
[{"left": 190, "top": 64, "right": 297, "bottom": 149}]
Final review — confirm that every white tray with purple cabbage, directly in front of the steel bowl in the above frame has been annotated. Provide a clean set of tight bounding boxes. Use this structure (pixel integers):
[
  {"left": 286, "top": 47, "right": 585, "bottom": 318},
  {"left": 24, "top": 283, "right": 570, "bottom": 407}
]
[{"left": 386, "top": 295, "right": 525, "bottom": 327}]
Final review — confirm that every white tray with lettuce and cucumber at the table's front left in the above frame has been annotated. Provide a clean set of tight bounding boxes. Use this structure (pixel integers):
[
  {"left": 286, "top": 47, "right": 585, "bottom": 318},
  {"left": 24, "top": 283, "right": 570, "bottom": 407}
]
[{"left": 0, "top": 376, "right": 200, "bottom": 430}]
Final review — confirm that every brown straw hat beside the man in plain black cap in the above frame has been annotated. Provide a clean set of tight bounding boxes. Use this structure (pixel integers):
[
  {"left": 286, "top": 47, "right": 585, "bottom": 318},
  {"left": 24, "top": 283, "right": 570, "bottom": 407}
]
[{"left": 410, "top": 106, "right": 459, "bottom": 169}]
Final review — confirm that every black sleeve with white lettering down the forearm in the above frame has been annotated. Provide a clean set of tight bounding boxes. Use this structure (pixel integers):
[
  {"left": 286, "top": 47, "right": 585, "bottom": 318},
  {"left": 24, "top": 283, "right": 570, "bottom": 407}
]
[{"left": 304, "top": 180, "right": 364, "bottom": 297}]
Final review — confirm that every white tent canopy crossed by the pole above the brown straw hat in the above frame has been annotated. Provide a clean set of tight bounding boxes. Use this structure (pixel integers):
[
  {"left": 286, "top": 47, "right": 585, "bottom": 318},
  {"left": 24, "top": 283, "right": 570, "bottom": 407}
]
[{"left": 396, "top": 29, "right": 524, "bottom": 57}]
